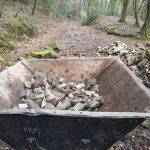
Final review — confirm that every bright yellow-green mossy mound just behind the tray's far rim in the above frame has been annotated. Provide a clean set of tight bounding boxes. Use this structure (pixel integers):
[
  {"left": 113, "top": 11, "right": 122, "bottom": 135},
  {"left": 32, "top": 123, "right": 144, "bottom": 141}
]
[{"left": 25, "top": 47, "right": 57, "bottom": 59}]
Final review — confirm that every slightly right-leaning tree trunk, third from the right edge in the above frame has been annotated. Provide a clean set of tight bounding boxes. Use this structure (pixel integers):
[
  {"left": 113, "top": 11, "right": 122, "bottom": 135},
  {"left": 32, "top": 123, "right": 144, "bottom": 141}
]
[{"left": 120, "top": 0, "right": 129, "bottom": 22}]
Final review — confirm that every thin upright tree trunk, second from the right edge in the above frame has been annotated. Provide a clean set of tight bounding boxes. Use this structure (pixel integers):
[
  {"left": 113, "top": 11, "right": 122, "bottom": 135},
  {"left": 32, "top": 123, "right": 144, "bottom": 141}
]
[{"left": 134, "top": 0, "right": 140, "bottom": 27}]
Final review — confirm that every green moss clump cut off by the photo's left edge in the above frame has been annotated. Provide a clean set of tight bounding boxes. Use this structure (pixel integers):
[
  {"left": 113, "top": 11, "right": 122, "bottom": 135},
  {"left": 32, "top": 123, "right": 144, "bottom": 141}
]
[{"left": 0, "top": 29, "right": 16, "bottom": 54}]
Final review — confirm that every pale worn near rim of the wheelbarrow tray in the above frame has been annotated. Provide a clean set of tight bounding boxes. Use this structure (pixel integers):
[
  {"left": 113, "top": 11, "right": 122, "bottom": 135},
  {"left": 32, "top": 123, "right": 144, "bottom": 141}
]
[{"left": 0, "top": 109, "right": 150, "bottom": 119}]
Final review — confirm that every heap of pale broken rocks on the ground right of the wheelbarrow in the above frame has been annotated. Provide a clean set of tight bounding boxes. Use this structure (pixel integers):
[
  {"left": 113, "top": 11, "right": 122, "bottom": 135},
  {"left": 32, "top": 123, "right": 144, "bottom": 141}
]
[{"left": 98, "top": 41, "right": 150, "bottom": 88}]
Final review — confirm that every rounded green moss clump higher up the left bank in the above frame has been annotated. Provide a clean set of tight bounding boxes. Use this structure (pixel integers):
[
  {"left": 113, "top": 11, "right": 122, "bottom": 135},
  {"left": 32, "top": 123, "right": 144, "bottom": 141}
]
[{"left": 6, "top": 20, "right": 34, "bottom": 40}]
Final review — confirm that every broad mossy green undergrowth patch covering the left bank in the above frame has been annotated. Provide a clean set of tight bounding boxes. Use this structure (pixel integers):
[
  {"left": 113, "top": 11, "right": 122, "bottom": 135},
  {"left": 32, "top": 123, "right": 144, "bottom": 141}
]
[{"left": 0, "top": 17, "right": 36, "bottom": 54}]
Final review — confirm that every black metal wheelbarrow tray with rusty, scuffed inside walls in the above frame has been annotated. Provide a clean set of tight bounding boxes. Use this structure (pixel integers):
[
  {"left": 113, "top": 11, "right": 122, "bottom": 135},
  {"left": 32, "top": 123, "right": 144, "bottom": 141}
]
[{"left": 0, "top": 58, "right": 150, "bottom": 150}]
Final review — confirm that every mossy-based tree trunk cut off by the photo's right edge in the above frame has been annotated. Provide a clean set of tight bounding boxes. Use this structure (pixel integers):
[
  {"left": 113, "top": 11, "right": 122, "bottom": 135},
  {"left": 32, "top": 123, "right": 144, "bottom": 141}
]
[{"left": 141, "top": 0, "right": 150, "bottom": 38}]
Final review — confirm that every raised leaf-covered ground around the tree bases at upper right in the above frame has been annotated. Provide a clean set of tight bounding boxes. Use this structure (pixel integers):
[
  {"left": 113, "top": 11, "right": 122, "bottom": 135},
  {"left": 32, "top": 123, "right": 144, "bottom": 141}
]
[{"left": 98, "top": 16, "right": 143, "bottom": 39}]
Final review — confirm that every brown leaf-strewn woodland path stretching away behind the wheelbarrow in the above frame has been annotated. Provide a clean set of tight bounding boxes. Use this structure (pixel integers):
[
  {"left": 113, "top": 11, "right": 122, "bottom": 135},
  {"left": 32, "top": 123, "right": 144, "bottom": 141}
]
[{"left": 0, "top": 19, "right": 149, "bottom": 70}]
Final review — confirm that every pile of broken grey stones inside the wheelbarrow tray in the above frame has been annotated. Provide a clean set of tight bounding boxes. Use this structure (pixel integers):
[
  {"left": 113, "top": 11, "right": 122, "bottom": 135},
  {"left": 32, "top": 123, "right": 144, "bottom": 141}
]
[{"left": 14, "top": 72, "right": 104, "bottom": 111}]
